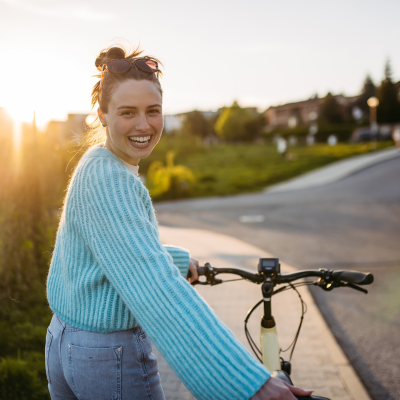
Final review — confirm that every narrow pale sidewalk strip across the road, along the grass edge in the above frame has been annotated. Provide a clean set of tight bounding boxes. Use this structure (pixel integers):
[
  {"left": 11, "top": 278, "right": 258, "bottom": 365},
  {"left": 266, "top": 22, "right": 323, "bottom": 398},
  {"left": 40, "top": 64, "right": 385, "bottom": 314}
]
[{"left": 265, "top": 147, "right": 400, "bottom": 193}]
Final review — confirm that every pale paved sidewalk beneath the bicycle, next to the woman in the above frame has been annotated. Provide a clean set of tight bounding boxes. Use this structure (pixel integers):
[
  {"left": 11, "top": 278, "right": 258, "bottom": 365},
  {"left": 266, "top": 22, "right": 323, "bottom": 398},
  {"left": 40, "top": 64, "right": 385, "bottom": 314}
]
[{"left": 154, "top": 226, "right": 370, "bottom": 400}]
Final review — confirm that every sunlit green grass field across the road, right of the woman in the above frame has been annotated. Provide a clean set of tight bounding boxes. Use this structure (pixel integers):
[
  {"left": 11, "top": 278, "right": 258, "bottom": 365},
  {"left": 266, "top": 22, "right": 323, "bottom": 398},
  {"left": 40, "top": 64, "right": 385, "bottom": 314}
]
[{"left": 148, "top": 142, "right": 393, "bottom": 200}]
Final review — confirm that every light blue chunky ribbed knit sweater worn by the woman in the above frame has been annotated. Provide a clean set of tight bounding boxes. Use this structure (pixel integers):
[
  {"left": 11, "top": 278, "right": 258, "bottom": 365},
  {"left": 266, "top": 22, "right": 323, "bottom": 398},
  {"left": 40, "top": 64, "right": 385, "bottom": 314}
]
[{"left": 47, "top": 147, "right": 270, "bottom": 400}]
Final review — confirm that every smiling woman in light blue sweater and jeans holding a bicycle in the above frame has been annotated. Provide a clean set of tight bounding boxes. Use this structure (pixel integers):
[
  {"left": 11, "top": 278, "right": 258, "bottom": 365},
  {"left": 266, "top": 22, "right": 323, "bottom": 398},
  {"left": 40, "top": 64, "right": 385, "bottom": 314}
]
[{"left": 46, "top": 46, "right": 310, "bottom": 400}]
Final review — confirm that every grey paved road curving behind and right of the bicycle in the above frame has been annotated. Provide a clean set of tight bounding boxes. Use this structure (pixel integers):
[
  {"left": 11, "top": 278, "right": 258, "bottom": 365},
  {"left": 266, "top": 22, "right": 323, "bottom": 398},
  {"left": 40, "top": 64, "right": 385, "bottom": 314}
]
[{"left": 156, "top": 157, "right": 400, "bottom": 400}]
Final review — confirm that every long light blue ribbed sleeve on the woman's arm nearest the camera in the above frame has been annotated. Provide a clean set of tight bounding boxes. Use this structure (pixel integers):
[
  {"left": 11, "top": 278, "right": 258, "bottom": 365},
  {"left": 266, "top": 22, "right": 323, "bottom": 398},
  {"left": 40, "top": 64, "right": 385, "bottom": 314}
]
[{"left": 74, "top": 157, "right": 270, "bottom": 400}]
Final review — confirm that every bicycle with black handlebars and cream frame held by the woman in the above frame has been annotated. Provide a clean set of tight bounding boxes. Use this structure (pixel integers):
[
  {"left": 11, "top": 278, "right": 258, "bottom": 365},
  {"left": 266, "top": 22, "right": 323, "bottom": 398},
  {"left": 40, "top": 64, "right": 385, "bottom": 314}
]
[{"left": 188, "top": 258, "right": 374, "bottom": 400}]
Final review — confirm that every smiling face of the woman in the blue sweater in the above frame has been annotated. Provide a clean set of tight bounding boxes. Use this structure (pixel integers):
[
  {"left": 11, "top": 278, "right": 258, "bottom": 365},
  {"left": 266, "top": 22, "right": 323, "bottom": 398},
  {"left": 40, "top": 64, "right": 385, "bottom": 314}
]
[{"left": 99, "top": 79, "right": 164, "bottom": 165}]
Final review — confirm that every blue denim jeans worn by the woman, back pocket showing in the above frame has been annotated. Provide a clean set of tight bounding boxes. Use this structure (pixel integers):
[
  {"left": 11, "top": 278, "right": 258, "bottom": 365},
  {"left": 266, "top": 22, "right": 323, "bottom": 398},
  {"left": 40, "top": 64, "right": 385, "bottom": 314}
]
[{"left": 45, "top": 314, "right": 165, "bottom": 400}]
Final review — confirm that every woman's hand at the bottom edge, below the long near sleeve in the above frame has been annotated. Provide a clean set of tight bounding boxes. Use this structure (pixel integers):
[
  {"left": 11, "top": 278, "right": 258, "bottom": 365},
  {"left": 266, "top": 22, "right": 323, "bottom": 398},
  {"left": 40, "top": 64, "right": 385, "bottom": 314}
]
[{"left": 252, "top": 377, "right": 313, "bottom": 400}]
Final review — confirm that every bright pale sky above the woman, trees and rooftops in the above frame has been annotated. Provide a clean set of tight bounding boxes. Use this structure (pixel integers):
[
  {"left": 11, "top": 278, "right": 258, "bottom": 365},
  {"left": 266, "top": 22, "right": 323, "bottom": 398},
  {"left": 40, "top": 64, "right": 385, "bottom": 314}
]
[{"left": 0, "top": 0, "right": 400, "bottom": 126}]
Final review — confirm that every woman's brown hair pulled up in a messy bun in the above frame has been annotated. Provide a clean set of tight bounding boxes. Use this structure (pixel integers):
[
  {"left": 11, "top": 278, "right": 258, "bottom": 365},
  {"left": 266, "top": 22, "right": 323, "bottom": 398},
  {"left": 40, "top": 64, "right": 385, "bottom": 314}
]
[{"left": 92, "top": 45, "right": 162, "bottom": 113}]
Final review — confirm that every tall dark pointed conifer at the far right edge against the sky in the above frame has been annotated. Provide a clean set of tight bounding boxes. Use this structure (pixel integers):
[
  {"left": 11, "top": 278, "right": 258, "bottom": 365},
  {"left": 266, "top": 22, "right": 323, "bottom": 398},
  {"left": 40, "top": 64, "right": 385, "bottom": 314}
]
[{"left": 377, "top": 60, "right": 400, "bottom": 124}]
